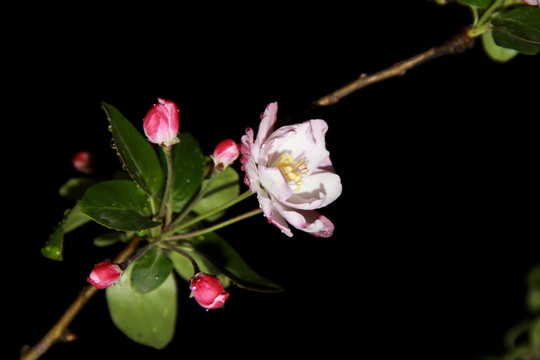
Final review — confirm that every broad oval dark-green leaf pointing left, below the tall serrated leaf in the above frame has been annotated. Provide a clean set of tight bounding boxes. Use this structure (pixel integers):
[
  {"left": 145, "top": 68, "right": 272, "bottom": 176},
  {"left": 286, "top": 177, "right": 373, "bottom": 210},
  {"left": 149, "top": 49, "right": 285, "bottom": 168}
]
[{"left": 81, "top": 180, "right": 159, "bottom": 231}]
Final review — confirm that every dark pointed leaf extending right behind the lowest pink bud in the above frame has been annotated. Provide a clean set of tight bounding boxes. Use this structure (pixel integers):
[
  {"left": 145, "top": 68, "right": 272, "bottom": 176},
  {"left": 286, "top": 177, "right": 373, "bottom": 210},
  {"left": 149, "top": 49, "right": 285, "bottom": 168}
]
[{"left": 192, "top": 232, "right": 283, "bottom": 292}]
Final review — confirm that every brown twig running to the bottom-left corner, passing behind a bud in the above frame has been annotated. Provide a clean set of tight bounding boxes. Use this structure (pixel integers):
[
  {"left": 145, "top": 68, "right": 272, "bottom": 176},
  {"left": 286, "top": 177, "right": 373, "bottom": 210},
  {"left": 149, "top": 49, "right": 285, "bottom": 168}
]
[{"left": 20, "top": 237, "right": 139, "bottom": 360}]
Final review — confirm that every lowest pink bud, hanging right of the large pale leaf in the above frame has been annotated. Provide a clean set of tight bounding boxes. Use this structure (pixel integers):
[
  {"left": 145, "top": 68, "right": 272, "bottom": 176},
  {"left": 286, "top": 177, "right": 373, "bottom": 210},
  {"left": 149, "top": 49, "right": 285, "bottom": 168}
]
[{"left": 189, "top": 272, "right": 229, "bottom": 310}]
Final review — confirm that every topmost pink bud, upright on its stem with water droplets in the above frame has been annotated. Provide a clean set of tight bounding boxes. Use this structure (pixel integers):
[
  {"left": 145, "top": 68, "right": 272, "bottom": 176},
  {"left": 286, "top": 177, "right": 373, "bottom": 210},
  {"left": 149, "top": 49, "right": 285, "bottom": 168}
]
[{"left": 143, "top": 98, "right": 180, "bottom": 147}]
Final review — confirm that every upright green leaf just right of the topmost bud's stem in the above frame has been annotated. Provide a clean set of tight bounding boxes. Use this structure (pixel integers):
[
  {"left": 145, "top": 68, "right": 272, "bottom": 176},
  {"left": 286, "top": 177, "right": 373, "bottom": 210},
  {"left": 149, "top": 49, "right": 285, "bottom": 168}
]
[{"left": 171, "top": 133, "right": 204, "bottom": 212}]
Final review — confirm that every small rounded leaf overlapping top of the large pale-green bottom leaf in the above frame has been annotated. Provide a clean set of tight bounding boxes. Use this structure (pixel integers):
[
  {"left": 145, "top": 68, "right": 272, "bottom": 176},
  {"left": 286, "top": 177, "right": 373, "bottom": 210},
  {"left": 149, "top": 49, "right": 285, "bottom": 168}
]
[{"left": 131, "top": 247, "right": 172, "bottom": 293}]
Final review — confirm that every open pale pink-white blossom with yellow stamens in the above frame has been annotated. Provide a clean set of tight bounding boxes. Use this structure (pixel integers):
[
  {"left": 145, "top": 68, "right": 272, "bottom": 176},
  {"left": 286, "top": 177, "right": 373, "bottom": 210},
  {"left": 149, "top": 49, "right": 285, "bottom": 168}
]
[{"left": 240, "top": 102, "right": 342, "bottom": 237}]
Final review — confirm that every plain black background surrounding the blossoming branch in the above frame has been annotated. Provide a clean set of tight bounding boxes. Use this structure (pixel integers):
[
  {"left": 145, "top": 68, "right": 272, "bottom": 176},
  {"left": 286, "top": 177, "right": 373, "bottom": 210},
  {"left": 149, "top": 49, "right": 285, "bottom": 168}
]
[{"left": 9, "top": 1, "right": 540, "bottom": 359}]
